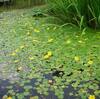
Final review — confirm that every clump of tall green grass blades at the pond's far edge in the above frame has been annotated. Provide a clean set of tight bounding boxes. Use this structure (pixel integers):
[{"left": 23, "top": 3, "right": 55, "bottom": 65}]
[{"left": 46, "top": 0, "right": 100, "bottom": 28}]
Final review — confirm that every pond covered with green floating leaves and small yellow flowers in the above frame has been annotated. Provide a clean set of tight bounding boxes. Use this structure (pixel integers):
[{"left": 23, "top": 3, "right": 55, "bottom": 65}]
[{"left": 0, "top": 8, "right": 100, "bottom": 99}]
